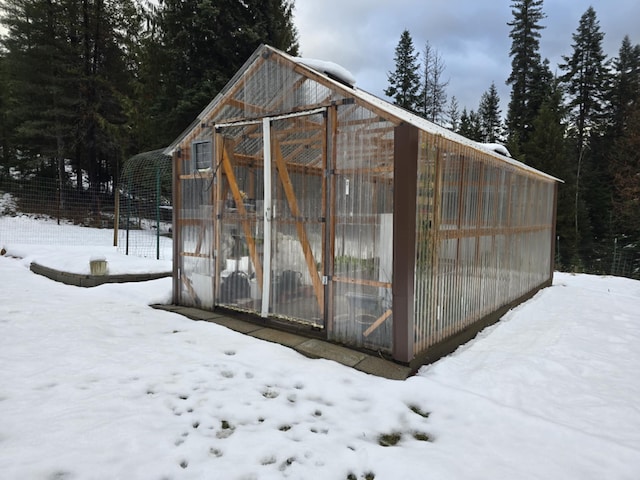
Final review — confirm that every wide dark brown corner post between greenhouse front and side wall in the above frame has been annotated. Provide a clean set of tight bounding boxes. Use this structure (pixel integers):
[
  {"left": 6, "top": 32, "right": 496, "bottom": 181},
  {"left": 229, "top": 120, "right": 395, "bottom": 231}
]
[{"left": 392, "top": 123, "right": 419, "bottom": 363}]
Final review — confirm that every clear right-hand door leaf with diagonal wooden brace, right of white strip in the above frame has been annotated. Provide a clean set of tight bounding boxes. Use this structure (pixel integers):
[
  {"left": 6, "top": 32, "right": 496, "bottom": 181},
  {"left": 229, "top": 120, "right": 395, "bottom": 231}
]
[{"left": 265, "top": 114, "right": 326, "bottom": 326}]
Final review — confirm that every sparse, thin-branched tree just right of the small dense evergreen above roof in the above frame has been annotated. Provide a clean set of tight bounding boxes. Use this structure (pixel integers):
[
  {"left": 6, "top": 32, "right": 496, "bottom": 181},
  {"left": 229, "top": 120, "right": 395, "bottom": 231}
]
[{"left": 420, "top": 42, "right": 449, "bottom": 124}]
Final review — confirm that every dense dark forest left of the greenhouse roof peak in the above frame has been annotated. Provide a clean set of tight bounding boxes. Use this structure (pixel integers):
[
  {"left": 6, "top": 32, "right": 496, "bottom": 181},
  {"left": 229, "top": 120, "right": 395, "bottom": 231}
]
[{"left": 0, "top": 0, "right": 298, "bottom": 191}]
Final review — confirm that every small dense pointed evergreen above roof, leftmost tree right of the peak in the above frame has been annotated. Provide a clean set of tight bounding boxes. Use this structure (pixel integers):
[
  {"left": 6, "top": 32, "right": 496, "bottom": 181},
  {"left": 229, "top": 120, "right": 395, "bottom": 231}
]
[{"left": 384, "top": 30, "right": 420, "bottom": 113}]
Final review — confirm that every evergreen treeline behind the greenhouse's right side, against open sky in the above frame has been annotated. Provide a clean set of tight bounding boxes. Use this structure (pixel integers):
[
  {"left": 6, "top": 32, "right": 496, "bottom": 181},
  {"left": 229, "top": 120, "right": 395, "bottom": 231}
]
[{"left": 385, "top": 0, "right": 640, "bottom": 278}]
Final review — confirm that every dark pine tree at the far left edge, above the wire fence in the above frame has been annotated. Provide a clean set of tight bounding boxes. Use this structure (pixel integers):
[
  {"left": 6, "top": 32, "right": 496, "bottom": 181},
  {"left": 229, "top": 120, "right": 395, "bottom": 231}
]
[{"left": 2, "top": 0, "right": 80, "bottom": 172}]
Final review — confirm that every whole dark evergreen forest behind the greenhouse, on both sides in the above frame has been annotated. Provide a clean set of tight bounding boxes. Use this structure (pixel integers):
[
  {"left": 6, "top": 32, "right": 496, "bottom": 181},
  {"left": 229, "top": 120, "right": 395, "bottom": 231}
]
[{"left": 0, "top": 0, "right": 640, "bottom": 277}]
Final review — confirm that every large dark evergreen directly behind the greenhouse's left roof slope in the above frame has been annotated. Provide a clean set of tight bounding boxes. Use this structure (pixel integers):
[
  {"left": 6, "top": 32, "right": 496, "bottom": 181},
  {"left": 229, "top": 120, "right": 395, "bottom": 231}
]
[{"left": 148, "top": 0, "right": 298, "bottom": 146}]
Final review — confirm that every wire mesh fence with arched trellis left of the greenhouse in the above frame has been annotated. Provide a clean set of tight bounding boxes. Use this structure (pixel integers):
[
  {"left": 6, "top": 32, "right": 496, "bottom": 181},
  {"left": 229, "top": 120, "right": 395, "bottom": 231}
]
[{"left": 0, "top": 154, "right": 172, "bottom": 260}]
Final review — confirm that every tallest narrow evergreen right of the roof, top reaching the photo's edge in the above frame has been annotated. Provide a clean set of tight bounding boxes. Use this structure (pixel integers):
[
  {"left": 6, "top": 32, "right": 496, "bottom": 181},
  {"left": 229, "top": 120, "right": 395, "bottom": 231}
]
[{"left": 507, "top": 0, "right": 546, "bottom": 149}]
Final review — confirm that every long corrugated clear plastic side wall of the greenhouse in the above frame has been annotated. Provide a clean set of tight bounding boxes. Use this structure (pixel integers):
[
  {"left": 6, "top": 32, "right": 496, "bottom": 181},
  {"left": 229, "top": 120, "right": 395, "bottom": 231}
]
[{"left": 414, "top": 132, "right": 556, "bottom": 356}]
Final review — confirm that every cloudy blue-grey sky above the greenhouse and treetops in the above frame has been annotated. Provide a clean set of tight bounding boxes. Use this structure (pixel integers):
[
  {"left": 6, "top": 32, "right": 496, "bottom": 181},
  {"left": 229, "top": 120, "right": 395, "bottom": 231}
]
[{"left": 294, "top": 0, "right": 640, "bottom": 115}]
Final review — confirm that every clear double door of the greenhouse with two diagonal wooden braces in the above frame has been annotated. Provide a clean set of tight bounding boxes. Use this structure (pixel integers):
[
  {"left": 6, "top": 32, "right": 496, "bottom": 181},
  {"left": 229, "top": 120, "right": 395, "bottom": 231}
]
[{"left": 216, "top": 109, "right": 327, "bottom": 328}]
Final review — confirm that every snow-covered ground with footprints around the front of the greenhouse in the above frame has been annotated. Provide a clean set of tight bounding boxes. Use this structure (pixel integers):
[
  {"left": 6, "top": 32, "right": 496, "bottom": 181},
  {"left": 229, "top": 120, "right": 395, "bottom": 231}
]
[{"left": 0, "top": 220, "right": 640, "bottom": 480}]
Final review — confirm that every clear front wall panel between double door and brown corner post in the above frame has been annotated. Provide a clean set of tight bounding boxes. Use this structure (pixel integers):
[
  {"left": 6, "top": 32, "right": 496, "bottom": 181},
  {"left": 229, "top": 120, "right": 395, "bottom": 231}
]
[{"left": 330, "top": 105, "right": 394, "bottom": 351}]
